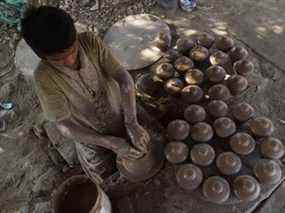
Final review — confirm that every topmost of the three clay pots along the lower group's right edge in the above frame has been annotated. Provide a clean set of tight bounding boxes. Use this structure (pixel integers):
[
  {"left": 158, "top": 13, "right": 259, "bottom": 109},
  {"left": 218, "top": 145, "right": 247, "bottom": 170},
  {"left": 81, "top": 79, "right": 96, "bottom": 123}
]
[{"left": 249, "top": 117, "right": 274, "bottom": 137}]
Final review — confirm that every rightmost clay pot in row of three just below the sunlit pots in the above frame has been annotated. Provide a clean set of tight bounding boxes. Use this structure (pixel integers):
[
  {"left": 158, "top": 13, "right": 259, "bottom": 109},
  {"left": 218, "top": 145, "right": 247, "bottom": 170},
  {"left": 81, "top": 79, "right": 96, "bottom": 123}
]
[{"left": 232, "top": 102, "right": 255, "bottom": 122}]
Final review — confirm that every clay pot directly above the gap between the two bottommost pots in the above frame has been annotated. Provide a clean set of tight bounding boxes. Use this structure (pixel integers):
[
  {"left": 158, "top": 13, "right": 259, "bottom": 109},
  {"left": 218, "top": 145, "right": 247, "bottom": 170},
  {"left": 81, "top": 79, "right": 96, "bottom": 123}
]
[{"left": 216, "top": 152, "right": 242, "bottom": 175}]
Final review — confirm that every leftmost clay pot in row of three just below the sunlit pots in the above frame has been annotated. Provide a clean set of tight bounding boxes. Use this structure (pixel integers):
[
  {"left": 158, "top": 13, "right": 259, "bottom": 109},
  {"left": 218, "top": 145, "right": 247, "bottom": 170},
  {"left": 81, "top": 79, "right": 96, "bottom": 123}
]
[{"left": 184, "top": 105, "right": 207, "bottom": 124}]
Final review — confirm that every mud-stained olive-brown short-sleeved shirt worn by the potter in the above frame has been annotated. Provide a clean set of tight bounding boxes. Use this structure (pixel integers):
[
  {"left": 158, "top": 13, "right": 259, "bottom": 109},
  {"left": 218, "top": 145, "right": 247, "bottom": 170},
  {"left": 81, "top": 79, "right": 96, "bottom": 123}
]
[{"left": 34, "top": 33, "right": 123, "bottom": 135}]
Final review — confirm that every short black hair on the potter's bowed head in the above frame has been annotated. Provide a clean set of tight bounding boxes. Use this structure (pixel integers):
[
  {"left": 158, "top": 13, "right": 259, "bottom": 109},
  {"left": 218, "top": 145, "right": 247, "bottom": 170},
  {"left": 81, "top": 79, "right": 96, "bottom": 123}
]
[{"left": 21, "top": 6, "right": 76, "bottom": 57}]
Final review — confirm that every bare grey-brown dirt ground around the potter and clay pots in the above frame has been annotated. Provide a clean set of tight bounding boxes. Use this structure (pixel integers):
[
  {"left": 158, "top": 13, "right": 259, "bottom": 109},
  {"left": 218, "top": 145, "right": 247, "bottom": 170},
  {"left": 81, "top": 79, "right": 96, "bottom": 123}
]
[{"left": 0, "top": 0, "right": 285, "bottom": 213}]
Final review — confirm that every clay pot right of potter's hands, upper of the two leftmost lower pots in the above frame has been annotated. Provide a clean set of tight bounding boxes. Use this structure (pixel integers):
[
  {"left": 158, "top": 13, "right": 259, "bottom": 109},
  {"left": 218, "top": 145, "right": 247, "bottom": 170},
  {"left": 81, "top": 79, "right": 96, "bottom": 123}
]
[{"left": 167, "top": 120, "right": 190, "bottom": 141}]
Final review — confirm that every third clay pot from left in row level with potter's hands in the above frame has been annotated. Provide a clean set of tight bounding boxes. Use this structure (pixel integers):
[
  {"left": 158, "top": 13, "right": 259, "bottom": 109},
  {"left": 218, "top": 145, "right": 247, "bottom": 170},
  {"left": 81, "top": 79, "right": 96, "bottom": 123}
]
[{"left": 213, "top": 117, "right": 236, "bottom": 138}]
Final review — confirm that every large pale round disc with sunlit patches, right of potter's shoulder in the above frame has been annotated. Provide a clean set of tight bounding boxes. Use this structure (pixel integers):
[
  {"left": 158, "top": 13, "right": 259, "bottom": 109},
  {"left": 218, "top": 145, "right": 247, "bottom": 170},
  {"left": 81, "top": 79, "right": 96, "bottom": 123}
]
[{"left": 104, "top": 14, "right": 171, "bottom": 70}]
